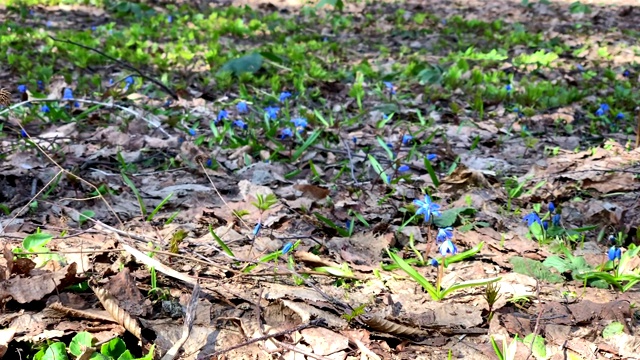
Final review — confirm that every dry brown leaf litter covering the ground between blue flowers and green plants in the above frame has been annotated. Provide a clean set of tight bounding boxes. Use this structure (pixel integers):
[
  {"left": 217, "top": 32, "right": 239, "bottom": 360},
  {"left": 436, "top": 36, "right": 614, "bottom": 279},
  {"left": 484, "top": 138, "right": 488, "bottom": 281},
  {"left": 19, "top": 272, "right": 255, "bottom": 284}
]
[{"left": 0, "top": 1, "right": 640, "bottom": 359}]
